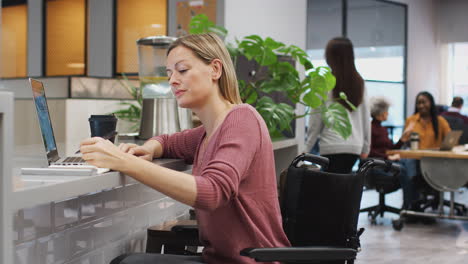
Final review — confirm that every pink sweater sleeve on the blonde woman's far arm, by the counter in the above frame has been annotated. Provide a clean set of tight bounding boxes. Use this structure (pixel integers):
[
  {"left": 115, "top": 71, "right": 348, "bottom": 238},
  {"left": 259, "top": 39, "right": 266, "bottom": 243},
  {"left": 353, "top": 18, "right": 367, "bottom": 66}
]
[{"left": 150, "top": 126, "right": 205, "bottom": 164}]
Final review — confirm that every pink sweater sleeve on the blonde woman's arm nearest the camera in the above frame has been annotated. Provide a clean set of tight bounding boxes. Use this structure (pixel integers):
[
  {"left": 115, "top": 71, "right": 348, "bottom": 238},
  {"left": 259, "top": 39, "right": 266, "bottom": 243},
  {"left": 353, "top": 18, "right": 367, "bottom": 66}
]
[{"left": 194, "top": 108, "right": 263, "bottom": 210}]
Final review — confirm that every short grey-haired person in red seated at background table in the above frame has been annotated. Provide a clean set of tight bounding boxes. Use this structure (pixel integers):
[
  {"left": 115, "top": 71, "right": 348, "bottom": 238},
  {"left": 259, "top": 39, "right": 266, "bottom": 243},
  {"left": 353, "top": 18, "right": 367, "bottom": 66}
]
[{"left": 369, "top": 97, "right": 414, "bottom": 208}]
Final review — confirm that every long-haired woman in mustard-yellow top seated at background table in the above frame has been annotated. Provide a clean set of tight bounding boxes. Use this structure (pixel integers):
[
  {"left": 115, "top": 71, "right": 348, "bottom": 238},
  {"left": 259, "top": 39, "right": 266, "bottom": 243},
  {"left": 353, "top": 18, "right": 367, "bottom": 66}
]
[{"left": 401, "top": 91, "right": 450, "bottom": 211}]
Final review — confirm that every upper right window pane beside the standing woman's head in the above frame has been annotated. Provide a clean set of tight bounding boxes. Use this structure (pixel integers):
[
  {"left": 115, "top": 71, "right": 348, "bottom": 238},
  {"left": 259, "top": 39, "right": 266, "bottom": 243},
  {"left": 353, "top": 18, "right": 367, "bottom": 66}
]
[{"left": 347, "top": 0, "right": 406, "bottom": 82}]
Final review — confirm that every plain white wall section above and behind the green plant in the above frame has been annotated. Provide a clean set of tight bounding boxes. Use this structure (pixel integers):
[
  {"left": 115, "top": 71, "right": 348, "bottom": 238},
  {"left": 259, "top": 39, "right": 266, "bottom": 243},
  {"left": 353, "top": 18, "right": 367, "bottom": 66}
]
[{"left": 224, "top": 0, "right": 307, "bottom": 153}]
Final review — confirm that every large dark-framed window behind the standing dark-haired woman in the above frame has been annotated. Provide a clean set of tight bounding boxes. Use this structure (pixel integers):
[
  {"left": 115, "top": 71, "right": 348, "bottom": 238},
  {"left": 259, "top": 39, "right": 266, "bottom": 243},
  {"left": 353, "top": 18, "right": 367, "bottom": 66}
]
[{"left": 307, "top": 0, "right": 407, "bottom": 140}]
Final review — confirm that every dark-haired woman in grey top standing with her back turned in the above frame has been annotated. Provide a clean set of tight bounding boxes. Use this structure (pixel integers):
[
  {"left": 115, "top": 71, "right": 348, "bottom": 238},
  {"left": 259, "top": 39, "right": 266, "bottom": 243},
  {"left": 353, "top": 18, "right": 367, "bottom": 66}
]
[{"left": 306, "top": 37, "right": 371, "bottom": 173}]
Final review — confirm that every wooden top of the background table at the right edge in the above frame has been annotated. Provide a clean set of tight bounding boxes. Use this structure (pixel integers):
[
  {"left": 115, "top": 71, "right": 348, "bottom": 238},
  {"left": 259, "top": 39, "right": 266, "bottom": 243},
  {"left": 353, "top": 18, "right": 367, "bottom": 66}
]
[{"left": 386, "top": 146, "right": 468, "bottom": 159}]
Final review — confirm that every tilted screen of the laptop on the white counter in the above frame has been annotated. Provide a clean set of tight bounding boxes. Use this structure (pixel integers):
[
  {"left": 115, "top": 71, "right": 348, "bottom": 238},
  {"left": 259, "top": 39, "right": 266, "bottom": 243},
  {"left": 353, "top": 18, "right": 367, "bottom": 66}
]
[{"left": 29, "top": 78, "right": 57, "bottom": 157}]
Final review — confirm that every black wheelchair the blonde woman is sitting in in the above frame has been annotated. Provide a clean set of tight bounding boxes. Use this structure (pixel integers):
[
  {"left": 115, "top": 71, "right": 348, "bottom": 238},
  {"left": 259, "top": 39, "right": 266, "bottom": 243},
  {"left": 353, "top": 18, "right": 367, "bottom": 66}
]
[{"left": 133, "top": 154, "right": 395, "bottom": 263}]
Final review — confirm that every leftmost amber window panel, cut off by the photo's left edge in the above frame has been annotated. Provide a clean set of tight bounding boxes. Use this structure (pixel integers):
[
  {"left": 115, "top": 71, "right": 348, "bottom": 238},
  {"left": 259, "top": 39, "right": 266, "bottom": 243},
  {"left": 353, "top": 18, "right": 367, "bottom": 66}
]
[{"left": 0, "top": 0, "right": 28, "bottom": 78}]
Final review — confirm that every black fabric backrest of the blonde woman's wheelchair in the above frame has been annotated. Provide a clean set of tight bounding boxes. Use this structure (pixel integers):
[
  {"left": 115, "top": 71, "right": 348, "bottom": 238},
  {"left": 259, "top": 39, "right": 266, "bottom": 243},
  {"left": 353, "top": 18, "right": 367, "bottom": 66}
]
[{"left": 280, "top": 154, "right": 364, "bottom": 248}]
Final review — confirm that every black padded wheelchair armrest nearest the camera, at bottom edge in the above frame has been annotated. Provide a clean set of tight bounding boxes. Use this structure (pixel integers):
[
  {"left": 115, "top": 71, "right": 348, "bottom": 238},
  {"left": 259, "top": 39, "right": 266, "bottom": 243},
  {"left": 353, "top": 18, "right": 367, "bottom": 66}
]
[{"left": 240, "top": 247, "right": 357, "bottom": 262}]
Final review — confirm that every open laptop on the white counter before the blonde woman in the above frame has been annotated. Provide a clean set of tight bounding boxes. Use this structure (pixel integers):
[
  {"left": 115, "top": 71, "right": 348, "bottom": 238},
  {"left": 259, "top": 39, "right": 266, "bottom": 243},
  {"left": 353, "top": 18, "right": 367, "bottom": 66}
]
[{"left": 21, "top": 78, "right": 109, "bottom": 175}]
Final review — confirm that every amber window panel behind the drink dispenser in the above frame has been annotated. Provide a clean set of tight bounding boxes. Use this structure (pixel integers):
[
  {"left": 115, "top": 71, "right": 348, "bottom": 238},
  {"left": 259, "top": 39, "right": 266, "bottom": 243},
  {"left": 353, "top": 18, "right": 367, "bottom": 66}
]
[{"left": 116, "top": 0, "right": 167, "bottom": 73}]
